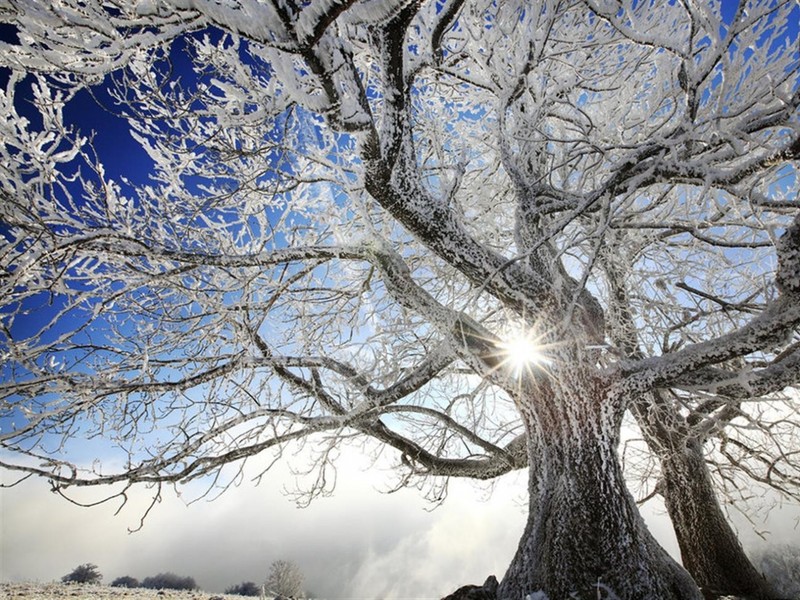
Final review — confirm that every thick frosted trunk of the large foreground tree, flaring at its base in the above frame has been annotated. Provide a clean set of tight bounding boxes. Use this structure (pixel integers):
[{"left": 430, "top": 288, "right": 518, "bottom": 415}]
[{"left": 498, "top": 370, "right": 701, "bottom": 600}]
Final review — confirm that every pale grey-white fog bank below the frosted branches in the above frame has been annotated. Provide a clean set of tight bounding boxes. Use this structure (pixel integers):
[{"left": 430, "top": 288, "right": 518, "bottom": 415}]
[{"left": 0, "top": 453, "right": 797, "bottom": 599}]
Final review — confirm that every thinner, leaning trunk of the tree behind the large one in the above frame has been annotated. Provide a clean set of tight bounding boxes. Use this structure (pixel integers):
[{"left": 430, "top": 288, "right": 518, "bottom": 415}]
[{"left": 661, "top": 443, "right": 778, "bottom": 600}]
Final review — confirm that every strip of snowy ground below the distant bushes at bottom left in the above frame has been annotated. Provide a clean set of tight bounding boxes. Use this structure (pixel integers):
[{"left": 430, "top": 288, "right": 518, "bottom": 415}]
[{"left": 0, "top": 583, "right": 250, "bottom": 600}]
